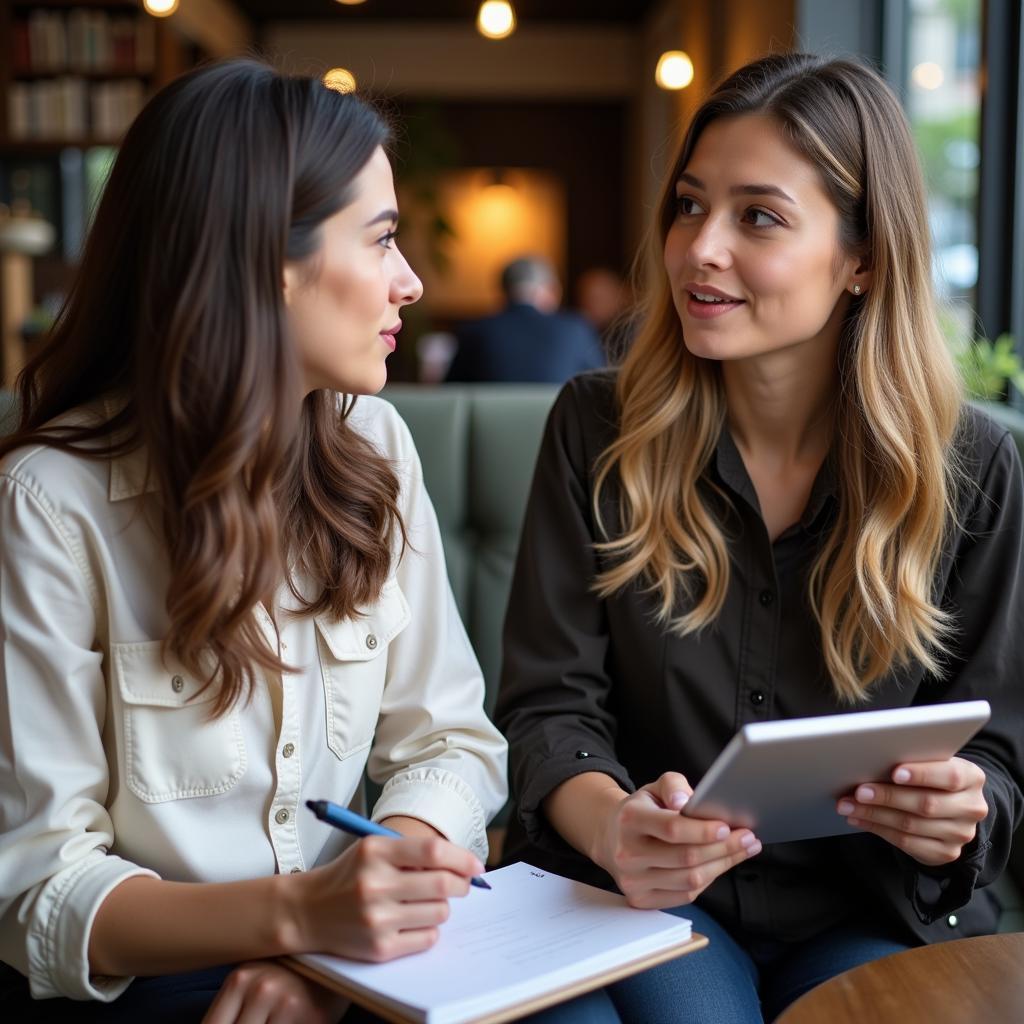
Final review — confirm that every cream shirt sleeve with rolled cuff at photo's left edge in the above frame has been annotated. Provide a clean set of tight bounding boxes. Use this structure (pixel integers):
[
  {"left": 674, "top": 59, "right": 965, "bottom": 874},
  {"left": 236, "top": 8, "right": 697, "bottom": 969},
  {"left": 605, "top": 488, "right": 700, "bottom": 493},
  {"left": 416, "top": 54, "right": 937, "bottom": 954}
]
[{"left": 0, "top": 474, "right": 153, "bottom": 1000}]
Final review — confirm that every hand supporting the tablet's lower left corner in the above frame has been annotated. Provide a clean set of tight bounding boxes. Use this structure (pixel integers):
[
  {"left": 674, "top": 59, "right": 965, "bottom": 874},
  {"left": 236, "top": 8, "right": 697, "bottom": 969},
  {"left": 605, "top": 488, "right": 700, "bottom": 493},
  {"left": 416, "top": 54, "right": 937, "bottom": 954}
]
[{"left": 592, "top": 772, "right": 761, "bottom": 909}]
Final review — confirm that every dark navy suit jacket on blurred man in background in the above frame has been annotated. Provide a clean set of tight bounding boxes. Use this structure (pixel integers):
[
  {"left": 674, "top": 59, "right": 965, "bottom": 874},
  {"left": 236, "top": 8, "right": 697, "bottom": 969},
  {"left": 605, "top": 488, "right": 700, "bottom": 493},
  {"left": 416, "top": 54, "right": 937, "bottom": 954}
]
[{"left": 446, "top": 303, "right": 605, "bottom": 384}]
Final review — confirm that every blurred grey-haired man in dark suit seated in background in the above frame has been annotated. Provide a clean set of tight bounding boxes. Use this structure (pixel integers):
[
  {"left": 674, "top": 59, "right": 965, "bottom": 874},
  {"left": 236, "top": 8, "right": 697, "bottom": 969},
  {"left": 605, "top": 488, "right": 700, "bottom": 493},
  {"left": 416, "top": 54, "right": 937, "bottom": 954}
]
[{"left": 446, "top": 256, "right": 605, "bottom": 384}]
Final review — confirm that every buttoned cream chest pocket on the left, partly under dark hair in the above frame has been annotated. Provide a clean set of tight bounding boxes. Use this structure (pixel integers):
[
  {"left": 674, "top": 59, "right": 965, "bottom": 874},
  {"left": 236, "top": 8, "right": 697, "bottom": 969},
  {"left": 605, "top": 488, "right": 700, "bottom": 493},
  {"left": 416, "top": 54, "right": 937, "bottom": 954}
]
[{"left": 112, "top": 641, "right": 246, "bottom": 804}]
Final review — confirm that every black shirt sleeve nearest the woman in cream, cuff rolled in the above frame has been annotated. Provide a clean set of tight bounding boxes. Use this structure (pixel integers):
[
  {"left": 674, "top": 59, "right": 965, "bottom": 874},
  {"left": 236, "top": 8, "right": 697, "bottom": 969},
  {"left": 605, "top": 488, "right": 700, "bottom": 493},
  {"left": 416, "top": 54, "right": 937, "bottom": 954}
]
[{"left": 495, "top": 382, "right": 634, "bottom": 849}]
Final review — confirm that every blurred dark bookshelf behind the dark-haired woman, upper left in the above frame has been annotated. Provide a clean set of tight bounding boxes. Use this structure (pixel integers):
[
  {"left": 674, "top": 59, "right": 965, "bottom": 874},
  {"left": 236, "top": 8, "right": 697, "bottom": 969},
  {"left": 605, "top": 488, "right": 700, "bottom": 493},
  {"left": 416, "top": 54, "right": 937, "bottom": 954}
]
[{"left": 0, "top": 0, "right": 221, "bottom": 387}]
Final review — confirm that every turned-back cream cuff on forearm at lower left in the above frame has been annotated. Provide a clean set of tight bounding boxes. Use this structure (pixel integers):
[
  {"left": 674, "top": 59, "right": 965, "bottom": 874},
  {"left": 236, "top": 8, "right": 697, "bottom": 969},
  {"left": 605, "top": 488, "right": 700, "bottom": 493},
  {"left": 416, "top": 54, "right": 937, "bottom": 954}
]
[{"left": 27, "top": 851, "right": 160, "bottom": 1002}]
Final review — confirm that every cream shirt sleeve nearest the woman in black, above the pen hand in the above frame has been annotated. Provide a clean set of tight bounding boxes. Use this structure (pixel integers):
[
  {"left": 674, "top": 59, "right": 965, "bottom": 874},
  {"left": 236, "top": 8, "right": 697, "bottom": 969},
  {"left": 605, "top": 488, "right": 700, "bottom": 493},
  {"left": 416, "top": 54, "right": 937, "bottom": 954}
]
[{"left": 368, "top": 407, "right": 508, "bottom": 860}]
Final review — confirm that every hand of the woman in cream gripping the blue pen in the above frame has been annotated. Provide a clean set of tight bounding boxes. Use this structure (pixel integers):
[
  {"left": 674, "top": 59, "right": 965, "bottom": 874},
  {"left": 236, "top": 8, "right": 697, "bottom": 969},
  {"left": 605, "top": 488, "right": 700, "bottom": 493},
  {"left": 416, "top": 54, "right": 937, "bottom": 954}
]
[{"left": 289, "top": 836, "right": 484, "bottom": 962}]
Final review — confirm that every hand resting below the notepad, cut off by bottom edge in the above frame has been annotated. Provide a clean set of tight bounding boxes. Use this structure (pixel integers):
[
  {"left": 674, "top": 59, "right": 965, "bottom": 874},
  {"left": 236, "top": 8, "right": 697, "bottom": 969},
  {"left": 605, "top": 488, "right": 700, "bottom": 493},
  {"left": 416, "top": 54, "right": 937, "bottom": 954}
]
[{"left": 203, "top": 961, "right": 349, "bottom": 1024}]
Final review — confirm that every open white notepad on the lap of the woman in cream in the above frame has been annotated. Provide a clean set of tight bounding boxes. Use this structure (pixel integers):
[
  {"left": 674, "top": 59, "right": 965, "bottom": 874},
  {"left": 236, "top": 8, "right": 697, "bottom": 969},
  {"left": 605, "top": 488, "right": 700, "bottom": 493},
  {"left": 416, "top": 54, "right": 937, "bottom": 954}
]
[{"left": 289, "top": 863, "right": 708, "bottom": 1024}]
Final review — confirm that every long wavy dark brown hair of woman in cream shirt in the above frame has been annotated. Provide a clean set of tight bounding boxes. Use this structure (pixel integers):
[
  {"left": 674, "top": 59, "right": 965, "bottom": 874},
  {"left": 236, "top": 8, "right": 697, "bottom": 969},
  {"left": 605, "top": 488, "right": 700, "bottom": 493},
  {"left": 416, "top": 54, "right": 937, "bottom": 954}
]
[{"left": 0, "top": 60, "right": 406, "bottom": 714}]
